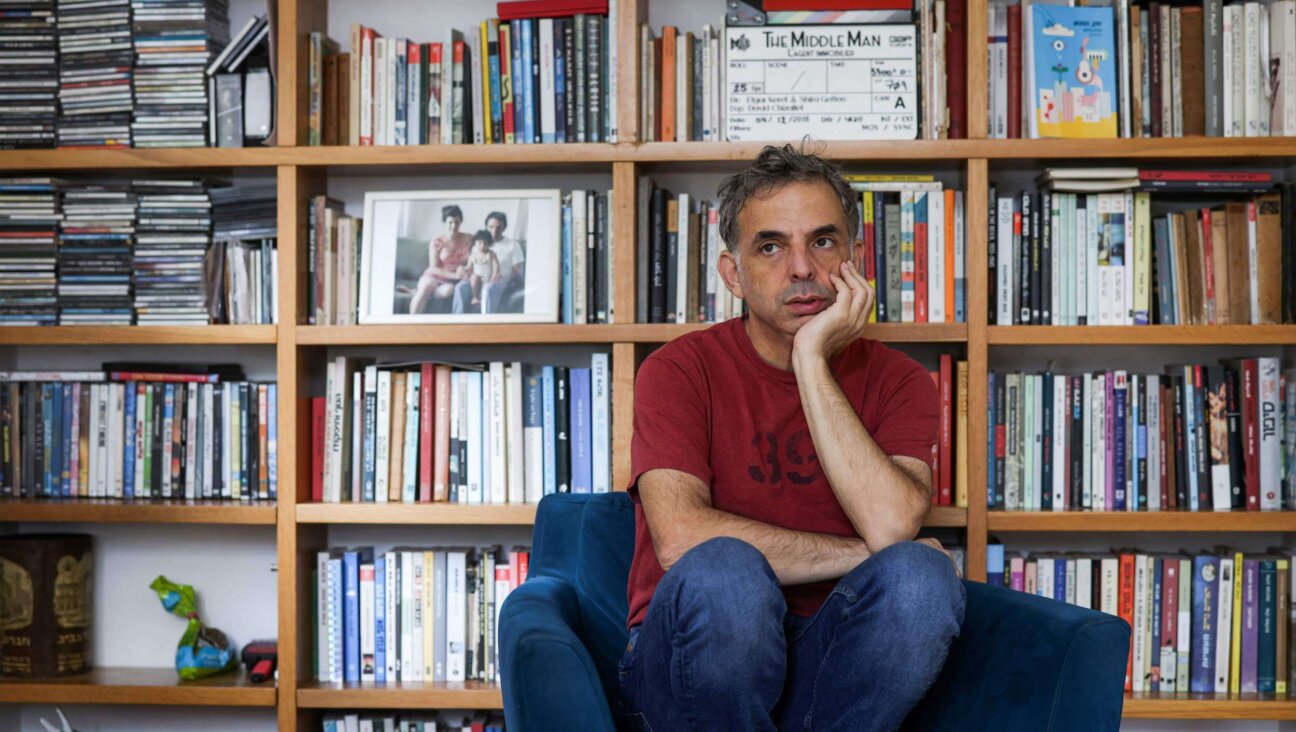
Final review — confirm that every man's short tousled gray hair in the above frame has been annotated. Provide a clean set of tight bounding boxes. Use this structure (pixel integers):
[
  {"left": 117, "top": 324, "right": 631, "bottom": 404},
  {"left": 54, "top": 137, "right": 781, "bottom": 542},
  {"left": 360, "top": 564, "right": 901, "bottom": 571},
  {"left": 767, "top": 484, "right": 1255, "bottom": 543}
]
[{"left": 718, "top": 145, "right": 859, "bottom": 251}]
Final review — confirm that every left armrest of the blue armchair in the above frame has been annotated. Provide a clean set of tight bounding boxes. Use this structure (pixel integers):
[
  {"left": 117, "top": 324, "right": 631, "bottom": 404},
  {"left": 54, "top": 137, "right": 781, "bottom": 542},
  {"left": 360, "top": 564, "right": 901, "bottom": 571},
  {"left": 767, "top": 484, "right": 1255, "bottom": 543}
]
[{"left": 499, "top": 577, "right": 616, "bottom": 732}]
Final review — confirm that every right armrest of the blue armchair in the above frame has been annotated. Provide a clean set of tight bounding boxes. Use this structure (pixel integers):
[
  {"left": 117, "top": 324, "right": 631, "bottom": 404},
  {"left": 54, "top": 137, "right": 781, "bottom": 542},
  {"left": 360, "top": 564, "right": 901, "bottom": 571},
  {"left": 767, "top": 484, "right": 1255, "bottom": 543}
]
[{"left": 905, "top": 582, "right": 1130, "bottom": 732}]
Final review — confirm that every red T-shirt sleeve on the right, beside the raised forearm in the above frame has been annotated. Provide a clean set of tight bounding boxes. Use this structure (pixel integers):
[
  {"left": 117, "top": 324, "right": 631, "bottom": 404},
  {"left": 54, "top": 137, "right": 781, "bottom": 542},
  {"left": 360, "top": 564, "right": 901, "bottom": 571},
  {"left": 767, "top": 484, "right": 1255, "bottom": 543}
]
[{"left": 871, "top": 358, "right": 941, "bottom": 465}]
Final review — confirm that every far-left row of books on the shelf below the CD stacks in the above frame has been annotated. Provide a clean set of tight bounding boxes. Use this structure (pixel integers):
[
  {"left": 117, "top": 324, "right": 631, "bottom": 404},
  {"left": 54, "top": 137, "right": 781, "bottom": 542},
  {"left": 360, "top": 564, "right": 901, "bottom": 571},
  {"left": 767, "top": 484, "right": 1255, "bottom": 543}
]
[{"left": 0, "top": 364, "right": 279, "bottom": 501}]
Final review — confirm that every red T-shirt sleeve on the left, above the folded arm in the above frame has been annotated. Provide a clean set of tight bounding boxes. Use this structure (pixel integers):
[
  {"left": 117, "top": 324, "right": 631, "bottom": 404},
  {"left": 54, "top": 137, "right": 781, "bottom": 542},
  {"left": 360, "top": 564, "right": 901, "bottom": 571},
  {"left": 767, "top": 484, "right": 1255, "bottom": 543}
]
[{"left": 626, "top": 351, "right": 713, "bottom": 499}]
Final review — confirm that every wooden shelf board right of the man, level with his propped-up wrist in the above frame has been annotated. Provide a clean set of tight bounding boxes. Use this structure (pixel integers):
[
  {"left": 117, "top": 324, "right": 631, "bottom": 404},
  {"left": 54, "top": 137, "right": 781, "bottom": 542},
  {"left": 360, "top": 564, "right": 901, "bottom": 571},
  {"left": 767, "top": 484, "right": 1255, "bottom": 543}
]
[{"left": 986, "top": 325, "right": 1296, "bottom": 346}]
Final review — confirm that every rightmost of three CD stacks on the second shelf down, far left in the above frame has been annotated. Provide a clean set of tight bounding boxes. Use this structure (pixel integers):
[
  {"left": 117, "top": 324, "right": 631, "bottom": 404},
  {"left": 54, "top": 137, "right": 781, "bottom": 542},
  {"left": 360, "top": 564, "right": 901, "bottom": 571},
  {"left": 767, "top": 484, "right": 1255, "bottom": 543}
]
[{"left": 133, "top": 179, "right": 211, "bottom": 325}]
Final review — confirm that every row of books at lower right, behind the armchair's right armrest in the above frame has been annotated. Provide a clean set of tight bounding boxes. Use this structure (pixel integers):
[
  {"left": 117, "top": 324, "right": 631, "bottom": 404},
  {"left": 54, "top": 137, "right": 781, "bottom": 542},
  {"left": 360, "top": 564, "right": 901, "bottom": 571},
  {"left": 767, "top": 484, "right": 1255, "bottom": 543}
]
[{"left": 986, "top": 544, "right": 1296, "bottom": 697}]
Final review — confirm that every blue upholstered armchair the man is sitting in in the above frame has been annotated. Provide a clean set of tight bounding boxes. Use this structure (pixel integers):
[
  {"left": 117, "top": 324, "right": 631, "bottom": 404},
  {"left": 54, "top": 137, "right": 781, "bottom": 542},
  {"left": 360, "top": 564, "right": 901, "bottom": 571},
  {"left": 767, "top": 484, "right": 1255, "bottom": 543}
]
[{"left": 499, "top": 492, "right": 1130, "bottom": 732}]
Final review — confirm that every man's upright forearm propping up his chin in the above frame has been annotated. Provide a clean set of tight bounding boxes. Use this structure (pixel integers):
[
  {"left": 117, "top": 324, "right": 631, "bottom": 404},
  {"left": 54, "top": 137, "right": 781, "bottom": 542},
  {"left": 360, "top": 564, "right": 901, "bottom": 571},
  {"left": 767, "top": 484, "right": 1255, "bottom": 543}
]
[{"left": 792, "top": 352, "right": 931, "bottom": 552}]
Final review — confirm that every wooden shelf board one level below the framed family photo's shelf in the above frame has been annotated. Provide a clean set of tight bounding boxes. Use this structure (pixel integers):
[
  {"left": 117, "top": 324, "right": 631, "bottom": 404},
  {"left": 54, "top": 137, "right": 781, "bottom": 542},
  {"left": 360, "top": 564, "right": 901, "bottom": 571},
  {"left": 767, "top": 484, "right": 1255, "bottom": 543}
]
[{"left": 297, "top": 503, "right": 535, "bottom": 526}]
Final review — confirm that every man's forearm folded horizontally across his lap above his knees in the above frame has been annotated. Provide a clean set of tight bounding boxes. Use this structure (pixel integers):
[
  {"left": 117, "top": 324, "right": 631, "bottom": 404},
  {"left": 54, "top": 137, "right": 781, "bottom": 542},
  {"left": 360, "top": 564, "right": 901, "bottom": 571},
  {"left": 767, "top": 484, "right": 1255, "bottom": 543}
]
[{"left": 657, "top": 507, "right": 868, "bottom": 584}]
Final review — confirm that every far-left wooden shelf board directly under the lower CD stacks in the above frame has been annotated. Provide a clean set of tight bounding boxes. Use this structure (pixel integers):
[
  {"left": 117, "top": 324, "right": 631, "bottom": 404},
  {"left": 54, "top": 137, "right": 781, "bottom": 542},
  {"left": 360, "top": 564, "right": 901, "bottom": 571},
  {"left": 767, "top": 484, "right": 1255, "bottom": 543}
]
[{"left": 0, "top": 325, "right": 277, "bottom": 346}]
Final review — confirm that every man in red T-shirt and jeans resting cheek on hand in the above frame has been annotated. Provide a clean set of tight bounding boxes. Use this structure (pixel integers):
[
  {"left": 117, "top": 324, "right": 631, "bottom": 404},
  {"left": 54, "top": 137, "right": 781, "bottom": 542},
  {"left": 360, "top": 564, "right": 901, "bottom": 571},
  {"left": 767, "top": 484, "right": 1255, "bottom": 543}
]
[{"left": 619, "top": 146, "right": 964, "bottom": 732}]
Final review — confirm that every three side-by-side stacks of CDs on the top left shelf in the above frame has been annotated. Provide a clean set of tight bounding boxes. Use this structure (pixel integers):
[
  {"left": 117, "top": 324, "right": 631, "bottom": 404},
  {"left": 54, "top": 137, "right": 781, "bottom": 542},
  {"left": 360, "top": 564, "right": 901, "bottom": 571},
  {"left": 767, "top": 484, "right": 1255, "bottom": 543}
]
[{"left": 0, "top": 0, "right": 229, "bottom": 149}]
